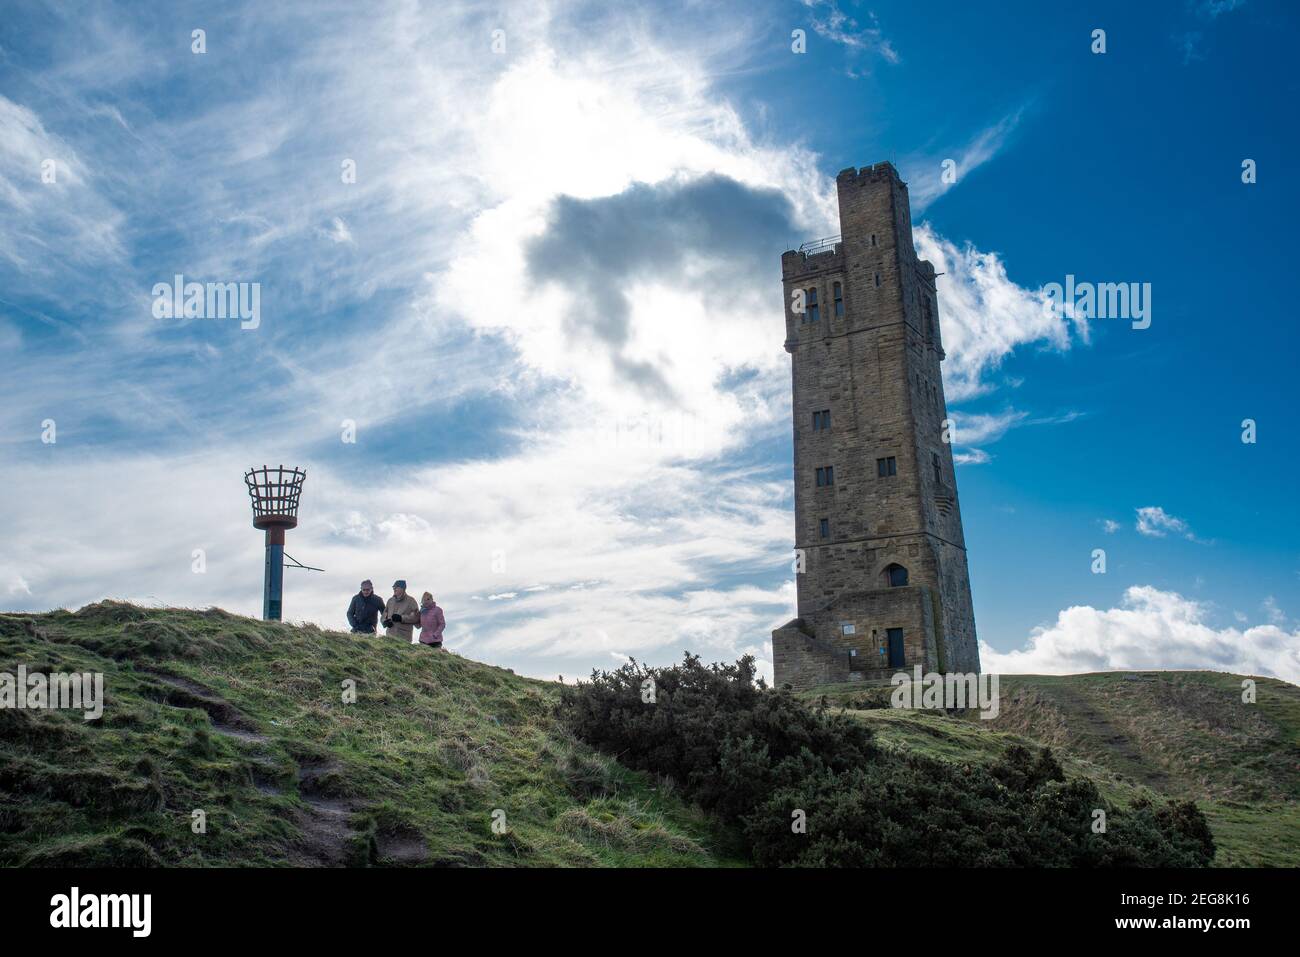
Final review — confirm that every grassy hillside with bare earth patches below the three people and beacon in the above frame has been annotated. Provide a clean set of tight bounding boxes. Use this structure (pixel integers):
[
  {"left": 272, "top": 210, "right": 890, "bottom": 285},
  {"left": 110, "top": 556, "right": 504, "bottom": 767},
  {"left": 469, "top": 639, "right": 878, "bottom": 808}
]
[{"left": 0, "top": 602, "right": 737, "bottom": 866}]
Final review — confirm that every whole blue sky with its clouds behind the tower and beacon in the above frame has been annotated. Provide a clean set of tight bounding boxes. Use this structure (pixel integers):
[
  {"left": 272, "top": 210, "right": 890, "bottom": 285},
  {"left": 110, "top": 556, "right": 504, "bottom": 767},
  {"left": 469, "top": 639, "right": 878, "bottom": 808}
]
[{"left": 0, "top": 0, "right": 1300, "bottom": 680}]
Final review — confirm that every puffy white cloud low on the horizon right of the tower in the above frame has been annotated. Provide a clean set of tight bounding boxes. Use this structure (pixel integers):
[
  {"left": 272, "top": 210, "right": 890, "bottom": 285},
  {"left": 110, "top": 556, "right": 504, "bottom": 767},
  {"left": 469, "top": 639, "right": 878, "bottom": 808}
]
[{"left": 980, "top": 585, "right": 1300, "bottom": 683}]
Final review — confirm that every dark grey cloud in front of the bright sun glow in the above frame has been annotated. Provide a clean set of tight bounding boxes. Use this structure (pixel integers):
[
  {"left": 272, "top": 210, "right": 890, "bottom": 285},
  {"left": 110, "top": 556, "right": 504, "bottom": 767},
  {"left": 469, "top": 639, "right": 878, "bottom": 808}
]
[{"left": 525, "top": 174, "right": 797, "bottom": 398}]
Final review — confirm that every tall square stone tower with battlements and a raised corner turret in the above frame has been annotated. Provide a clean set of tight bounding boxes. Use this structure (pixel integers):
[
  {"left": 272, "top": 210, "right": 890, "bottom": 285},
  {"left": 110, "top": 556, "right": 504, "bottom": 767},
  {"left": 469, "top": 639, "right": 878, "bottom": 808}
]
[{"left": 772, "top": 163, "right": 979, "bottom": 688}]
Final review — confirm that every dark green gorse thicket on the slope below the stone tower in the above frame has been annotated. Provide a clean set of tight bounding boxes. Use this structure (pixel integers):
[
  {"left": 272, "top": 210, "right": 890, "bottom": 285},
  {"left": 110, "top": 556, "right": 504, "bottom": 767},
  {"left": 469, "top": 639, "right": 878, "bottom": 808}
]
[{"left": 560, "top": 654, "right": 1214, "bottom": 867}]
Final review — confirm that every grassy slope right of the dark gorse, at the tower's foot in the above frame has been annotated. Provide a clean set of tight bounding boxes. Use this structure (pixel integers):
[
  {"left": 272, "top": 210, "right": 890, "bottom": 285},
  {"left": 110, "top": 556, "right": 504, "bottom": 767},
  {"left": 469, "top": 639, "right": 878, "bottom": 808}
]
[{"left": 801, "top": 671, "right": 1300, "bottom": 867}]
